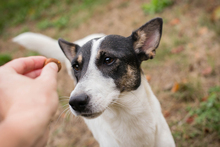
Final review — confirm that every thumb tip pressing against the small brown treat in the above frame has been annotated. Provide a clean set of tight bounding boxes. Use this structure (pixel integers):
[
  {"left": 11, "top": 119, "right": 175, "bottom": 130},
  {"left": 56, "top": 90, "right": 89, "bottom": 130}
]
[{"left": 39, "top": 62, "right": 58, "bottom": 83}]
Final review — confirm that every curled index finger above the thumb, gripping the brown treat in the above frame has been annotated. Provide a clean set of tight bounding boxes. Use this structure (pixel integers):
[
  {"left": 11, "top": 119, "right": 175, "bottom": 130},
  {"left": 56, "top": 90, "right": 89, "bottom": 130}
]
[{"left": 4, "top": 56, "right": 46, "bottom": 74}]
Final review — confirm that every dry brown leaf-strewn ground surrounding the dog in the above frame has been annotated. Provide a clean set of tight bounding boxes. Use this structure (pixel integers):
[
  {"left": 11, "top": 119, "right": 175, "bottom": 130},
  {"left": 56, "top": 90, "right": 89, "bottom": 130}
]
[{"left": 0, "top": 0, "right": 220, "bottom": 147}]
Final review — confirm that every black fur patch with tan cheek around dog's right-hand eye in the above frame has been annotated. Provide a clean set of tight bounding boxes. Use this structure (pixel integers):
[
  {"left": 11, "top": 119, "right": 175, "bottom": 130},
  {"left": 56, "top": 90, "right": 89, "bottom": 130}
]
[{"left": 96, "top": 35, "right": 141, "bottom": 92}]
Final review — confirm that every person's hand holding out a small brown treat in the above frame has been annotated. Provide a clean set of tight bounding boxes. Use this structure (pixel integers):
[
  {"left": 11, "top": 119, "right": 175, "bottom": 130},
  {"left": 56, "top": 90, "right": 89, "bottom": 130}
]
[{"left": 0, "top": 57, "right": 58, "bottom": 146}]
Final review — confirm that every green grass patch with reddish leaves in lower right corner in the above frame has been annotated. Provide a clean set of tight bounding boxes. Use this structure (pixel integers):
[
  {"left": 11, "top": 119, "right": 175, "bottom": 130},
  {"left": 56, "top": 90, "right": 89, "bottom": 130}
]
[{"left": 173, "top": 86, "right": 220, "bottom": 147}]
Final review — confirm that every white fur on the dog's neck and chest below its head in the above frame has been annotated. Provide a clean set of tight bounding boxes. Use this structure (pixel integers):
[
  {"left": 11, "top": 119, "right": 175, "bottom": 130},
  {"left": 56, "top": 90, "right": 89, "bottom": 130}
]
[{"left": 84, "top": 76, "right": 175, "bottom": 147}]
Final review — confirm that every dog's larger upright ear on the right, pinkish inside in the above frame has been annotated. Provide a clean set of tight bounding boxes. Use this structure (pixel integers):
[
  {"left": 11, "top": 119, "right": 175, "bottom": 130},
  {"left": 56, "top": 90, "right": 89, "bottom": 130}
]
[{"left": 130, "top": 18, "right": 163, "bottom": 61}]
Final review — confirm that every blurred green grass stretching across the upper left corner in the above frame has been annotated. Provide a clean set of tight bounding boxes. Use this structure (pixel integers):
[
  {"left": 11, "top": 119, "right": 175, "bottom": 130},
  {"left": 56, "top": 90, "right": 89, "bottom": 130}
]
[{"left": 0, "top": 0, "right": 109, "bottom": 34}]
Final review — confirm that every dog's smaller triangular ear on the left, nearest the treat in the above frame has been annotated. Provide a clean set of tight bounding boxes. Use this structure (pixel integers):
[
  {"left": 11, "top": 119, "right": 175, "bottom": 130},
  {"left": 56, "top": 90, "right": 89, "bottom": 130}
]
[{"left": 58, "top": 38, "right": 80, "bottom": 62}]
